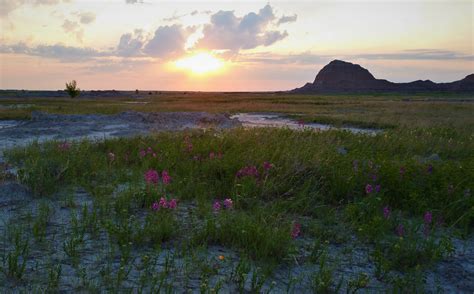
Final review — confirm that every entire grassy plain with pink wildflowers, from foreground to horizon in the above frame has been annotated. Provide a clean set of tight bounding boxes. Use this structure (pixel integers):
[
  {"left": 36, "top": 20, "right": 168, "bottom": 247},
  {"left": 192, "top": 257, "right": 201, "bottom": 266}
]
[{"left": 0, "top": 93, "right": 474, "bottom": 293}]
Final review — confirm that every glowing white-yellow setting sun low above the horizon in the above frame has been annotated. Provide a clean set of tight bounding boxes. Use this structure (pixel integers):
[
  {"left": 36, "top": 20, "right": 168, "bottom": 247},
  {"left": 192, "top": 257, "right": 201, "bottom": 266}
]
[{"left": 174, "top": 52, "right": 224, "bottom": 75}]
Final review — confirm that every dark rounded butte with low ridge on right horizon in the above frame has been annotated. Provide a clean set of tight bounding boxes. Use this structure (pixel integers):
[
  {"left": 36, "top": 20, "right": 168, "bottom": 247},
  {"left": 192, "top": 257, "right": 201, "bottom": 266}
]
[{"left": 291, "top": 60, "right": 474, "bottom": 93}]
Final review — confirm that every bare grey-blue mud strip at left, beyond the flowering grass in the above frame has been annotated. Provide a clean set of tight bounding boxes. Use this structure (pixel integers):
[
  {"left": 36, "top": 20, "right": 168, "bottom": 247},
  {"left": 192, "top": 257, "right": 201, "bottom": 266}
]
[{"left": 0, "top": 112, "right": 240, "bottom": 162}]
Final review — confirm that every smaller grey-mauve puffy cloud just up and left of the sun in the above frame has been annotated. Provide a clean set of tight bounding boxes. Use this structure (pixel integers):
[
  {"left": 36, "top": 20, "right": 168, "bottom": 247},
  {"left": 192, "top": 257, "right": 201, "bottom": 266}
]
[{"left": 143, "top": 24, "right": 195, "bottom": 58}]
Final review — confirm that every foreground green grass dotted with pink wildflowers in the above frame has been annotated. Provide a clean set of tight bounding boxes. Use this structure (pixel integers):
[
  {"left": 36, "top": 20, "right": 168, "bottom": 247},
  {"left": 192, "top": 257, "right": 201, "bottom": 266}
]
[{"left": 0, "top": 123, "right": 474, "bottom": 293}]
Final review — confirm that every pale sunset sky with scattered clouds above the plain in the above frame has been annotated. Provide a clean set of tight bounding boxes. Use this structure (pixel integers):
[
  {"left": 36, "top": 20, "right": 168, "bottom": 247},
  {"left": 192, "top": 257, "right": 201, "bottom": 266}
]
[{"left": 0, "top": 0, "right": 474, "bottom": 91}]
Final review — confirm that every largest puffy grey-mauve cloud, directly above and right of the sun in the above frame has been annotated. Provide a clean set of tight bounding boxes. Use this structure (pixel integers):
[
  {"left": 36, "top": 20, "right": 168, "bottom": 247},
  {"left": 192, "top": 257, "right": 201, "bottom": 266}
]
[{"left": 196, "top": 4, "right": 288, "bottom": 51}]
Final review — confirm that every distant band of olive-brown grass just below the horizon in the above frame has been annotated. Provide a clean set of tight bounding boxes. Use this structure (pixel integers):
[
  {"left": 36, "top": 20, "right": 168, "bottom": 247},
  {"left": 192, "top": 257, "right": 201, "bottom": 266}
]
[{"left": 0, "top": 91, "right": 474, "bottom": 130}]
